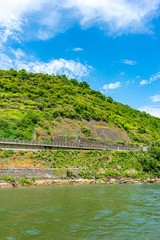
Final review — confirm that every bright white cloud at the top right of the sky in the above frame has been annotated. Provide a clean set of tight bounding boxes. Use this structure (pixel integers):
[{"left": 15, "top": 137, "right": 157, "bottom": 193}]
[{"left": 68, "top": 0, "right": 160, "bottom": 34}]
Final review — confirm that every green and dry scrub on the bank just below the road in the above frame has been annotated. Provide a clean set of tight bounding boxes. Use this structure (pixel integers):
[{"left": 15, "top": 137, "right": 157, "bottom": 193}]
[{"left": 0, "top": 147, "right": 160, "bottom": 181}]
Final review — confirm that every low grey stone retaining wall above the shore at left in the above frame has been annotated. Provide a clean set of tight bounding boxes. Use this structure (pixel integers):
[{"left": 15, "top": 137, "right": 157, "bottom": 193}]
[{"left": 0, "top": 168, "right": 80, "bottom": 179}]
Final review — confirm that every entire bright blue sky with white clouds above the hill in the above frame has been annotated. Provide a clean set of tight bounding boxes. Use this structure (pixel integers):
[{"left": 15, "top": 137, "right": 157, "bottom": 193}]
[{"left": 0, "top": 0, "right": 160, "bottom": 118}]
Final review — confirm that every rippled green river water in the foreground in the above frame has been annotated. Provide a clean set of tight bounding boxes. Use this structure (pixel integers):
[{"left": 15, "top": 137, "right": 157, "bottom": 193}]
[{"left": 0, "top": 184, "right": 160, "bottom": 240}]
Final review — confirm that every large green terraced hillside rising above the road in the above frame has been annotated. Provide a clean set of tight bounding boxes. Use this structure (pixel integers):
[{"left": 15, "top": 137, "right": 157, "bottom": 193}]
[{"left": 0, "top": 69, "right": 160, "bottom": 144}]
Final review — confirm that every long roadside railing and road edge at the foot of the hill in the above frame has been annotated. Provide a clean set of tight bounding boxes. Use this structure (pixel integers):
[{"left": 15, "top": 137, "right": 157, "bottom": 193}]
[{"left": 0, "top": 138, "right": 140, "bottom": 151}]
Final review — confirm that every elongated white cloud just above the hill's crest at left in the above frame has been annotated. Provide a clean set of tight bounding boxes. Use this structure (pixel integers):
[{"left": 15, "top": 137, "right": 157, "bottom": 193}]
[{"left": 0, "top": 49, "right": 92, "bottom": 80}]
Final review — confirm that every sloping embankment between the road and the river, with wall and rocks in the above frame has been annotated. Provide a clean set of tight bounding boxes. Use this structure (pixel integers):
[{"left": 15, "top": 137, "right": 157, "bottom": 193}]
[{"left": 0, "top": 148, "right": 160, "bottom": 187}]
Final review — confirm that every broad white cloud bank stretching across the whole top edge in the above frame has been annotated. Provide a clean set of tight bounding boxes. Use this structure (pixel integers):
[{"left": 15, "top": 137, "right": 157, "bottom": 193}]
[{"left": 0, "top": 0, "right": 160, "bottom": 44}]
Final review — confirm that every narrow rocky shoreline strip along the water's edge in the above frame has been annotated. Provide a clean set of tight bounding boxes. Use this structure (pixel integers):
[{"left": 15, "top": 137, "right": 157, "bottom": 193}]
[{"left": 0, "top": 177, "right": 160, "bottom": 188}]
